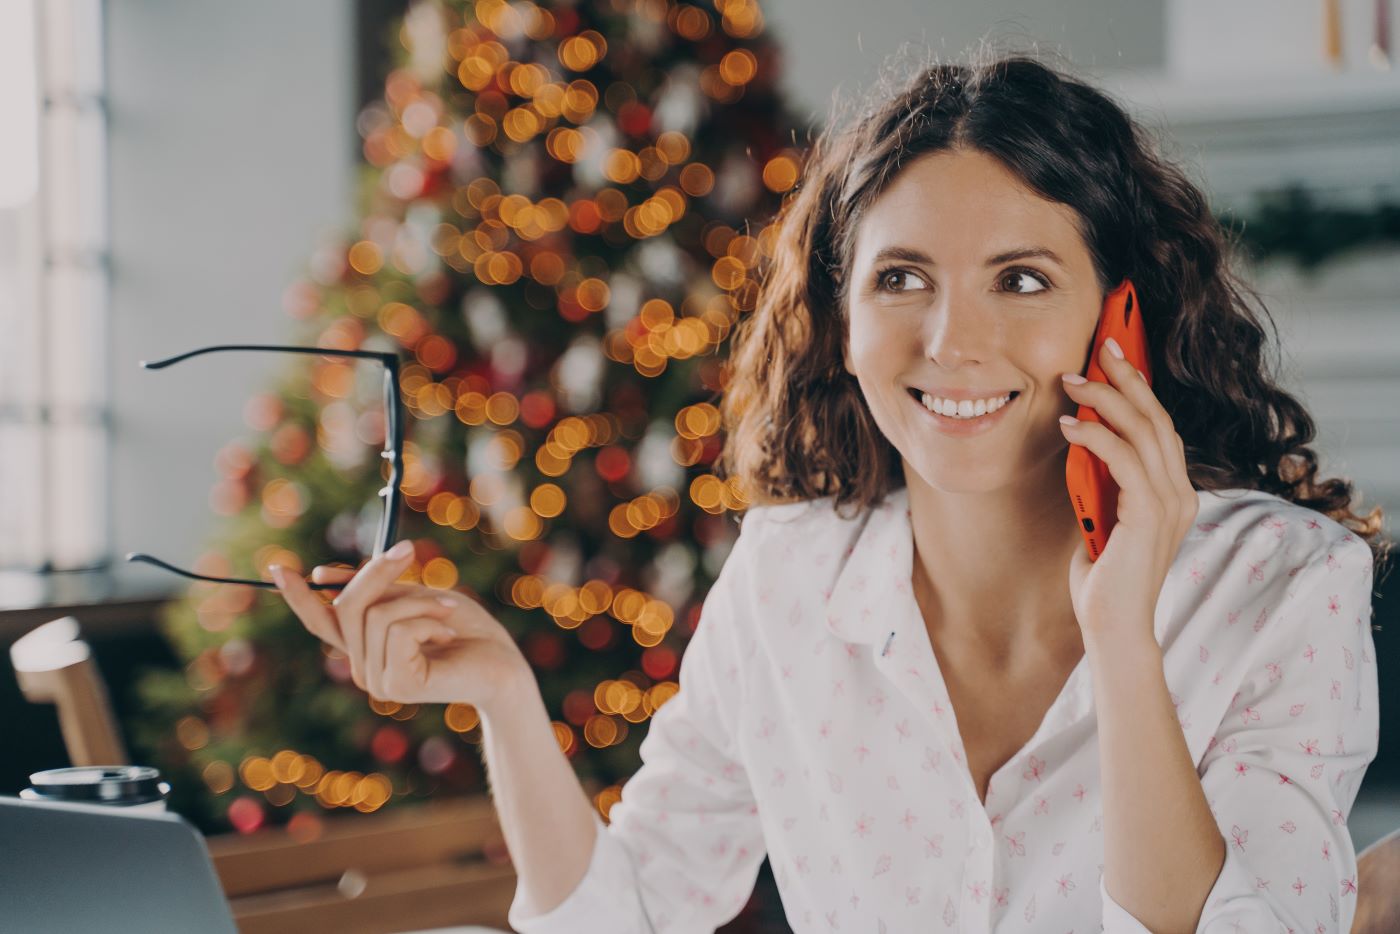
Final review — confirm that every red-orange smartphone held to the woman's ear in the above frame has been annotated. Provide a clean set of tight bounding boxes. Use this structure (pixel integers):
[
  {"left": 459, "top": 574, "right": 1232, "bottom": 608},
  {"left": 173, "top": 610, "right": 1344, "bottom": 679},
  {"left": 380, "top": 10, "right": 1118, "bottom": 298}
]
[{"left": 1064, "top": 279, "right": 1152, "bottom": 562}]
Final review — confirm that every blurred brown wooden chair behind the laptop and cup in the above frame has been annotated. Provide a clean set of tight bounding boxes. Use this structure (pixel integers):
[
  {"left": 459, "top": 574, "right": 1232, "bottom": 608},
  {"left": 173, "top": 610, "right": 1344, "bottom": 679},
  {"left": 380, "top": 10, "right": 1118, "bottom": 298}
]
[{"left": 10, "top": 616, "right": 515, "bottom": 934}]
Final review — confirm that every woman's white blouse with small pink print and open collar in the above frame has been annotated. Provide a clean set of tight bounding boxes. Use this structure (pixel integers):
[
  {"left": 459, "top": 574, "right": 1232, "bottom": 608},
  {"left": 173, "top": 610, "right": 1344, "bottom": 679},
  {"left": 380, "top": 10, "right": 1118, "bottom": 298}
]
[{"left": 508, "top": 489, "right": 1380, "bottom": 934}]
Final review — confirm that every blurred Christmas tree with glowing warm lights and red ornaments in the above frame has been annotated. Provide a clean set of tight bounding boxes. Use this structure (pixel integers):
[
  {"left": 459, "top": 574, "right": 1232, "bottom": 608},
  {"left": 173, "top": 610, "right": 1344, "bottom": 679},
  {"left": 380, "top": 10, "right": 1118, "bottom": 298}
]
[{"left": 132, "top": 0, "right": 812, "bottom": 879}]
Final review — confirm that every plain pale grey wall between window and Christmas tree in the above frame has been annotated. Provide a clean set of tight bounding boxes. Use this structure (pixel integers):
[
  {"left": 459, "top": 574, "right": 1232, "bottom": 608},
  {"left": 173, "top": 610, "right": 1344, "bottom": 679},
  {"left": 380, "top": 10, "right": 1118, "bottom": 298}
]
[{"left": 106, "top": 0, "right": 357, "bottom": 590}]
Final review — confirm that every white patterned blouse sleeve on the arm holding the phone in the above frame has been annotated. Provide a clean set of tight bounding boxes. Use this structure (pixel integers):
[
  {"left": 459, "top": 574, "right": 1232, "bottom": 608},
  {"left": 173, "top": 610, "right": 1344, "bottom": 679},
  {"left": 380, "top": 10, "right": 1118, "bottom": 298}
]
[{"left": 1099, "top": 535, "right": 1380, "bottom": 934}]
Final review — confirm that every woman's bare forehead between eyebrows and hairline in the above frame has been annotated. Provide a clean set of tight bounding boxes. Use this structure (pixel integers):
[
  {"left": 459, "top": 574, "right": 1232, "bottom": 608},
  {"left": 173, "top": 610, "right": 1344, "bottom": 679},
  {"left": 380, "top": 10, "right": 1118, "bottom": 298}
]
[{"left": 855, "top": 151, "right": 1088, "bottom": 263}]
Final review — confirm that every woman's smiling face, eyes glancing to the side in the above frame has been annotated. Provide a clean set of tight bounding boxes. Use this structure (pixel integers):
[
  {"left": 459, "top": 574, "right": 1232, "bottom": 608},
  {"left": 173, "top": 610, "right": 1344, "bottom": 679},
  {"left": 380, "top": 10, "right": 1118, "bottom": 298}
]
[{"left": 846, "top": 151, "right": 1103, "bottom": 492}]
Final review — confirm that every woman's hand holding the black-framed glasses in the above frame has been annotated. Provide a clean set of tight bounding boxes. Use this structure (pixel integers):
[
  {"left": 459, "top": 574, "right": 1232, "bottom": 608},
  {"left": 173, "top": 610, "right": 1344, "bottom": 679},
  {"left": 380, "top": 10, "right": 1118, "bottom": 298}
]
[{"left": 273, "top": 548, "right": 533, "bottom": 713}]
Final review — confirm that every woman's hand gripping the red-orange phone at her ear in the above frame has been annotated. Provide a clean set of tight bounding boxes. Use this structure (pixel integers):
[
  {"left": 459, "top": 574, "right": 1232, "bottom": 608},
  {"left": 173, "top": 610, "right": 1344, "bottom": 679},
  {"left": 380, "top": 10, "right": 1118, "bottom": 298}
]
[{"left": 1061, "top": 342, "right": 1200, "bottom": 643}]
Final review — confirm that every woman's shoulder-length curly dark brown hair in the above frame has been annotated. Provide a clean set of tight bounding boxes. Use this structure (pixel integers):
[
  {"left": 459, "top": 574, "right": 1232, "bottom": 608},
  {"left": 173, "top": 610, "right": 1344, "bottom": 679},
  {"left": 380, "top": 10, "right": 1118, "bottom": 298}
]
[{"left": 715, "top": 45, "right": 1393, "bottom": 585}]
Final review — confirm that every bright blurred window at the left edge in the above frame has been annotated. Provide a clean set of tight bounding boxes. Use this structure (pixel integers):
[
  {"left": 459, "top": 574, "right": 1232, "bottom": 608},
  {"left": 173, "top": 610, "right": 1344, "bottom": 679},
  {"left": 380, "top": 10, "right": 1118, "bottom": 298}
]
[{"left": 0, "top": 0, "right": 111, "bottom": 601}]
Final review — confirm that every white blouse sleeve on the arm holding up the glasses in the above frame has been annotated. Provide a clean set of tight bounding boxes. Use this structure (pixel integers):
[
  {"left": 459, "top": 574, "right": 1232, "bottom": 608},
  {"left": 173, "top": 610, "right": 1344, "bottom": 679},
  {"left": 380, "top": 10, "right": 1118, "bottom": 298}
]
[{"left": 507, "top": 511, "right": 764, "bottom": 934}]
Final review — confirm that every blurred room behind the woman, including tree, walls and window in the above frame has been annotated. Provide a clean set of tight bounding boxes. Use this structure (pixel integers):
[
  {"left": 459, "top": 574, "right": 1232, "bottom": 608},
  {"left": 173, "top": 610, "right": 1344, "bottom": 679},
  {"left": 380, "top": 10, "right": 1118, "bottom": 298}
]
[{"left": 0, "top": 0, "right": 1400, "bottom": 931}]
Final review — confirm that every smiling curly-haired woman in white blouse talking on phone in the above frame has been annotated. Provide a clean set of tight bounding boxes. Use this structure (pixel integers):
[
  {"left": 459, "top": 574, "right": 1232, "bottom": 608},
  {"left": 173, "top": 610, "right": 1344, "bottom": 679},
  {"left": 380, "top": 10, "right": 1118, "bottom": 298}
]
[{"left": 270, "top": 56, "right": 1382, "bottom": 933}]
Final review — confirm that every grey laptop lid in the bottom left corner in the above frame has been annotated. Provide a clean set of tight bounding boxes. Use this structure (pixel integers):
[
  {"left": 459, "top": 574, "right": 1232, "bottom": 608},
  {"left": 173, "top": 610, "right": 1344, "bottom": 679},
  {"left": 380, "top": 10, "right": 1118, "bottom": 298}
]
[{"left": 0, "top": 795, "right": 238, "bottom": 934}]
